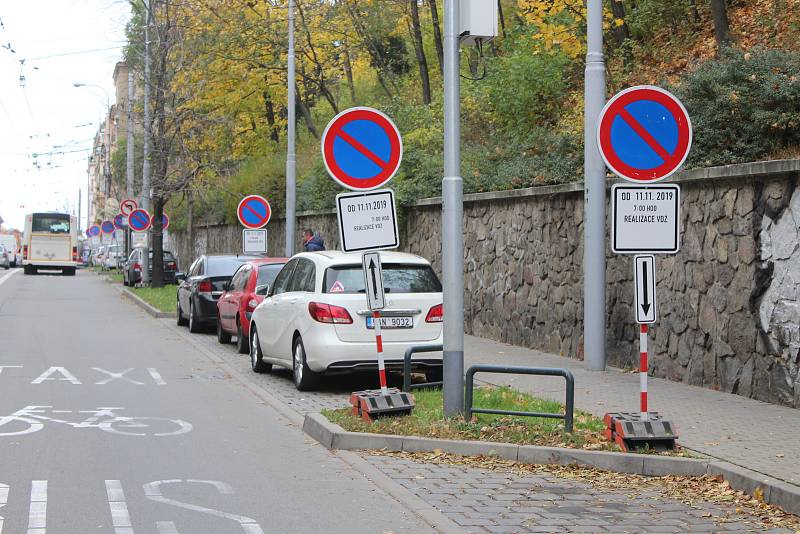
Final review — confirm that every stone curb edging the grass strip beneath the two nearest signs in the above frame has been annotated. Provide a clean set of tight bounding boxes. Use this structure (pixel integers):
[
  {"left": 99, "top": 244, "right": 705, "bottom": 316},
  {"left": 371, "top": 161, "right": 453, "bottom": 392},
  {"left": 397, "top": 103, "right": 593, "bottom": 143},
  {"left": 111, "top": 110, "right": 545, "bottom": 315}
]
[{"left": 303, "top": 413, "right": 800, "bottom": 515}]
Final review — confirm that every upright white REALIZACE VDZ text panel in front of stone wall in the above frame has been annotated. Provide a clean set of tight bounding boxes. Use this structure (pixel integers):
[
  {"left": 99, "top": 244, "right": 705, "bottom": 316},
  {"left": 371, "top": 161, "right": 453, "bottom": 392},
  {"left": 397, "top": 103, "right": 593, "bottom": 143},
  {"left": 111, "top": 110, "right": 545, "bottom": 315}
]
[{"left": 611, "top": 184, "right": 681, "bottom": 254}]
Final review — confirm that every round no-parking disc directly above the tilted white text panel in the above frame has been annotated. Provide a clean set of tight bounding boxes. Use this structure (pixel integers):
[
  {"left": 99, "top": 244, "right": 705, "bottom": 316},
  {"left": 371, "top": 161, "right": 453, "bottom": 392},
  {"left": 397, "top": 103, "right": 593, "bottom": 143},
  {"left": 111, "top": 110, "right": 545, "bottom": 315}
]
[{"left": 322, "top": 107, "right": 403, "bottom": 191}]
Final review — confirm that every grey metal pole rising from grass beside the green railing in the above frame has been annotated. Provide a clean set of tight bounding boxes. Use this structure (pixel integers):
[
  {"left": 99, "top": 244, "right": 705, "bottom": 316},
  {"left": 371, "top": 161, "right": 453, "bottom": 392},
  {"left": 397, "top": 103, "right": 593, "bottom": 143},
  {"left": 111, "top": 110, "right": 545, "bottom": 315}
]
[{"left": 442, "top": 0, "right": 464, "bottom": 417}]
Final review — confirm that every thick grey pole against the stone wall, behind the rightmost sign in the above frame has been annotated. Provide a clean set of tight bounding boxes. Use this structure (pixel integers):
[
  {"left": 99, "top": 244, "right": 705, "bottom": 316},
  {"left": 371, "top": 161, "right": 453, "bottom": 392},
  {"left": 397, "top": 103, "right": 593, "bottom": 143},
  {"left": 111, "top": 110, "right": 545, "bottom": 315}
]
[{"left": 583, "top": 0, "right": 606, "bottom": 371}]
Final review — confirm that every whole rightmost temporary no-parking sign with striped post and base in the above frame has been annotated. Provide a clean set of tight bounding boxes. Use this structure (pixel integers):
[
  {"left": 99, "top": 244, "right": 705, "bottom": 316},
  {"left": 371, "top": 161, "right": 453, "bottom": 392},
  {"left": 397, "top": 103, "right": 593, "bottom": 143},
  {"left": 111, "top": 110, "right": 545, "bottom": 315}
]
[{"left": 597, "top": 85, "right": 692, "bottom": 450}]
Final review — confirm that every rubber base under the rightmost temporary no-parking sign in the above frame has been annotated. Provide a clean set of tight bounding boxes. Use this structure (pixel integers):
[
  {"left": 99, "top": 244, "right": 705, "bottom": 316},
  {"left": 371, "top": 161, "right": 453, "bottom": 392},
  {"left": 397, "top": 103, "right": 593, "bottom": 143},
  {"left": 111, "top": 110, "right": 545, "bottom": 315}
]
[{"left": 603, "top": 412, "right": 678, "bottom": 452}]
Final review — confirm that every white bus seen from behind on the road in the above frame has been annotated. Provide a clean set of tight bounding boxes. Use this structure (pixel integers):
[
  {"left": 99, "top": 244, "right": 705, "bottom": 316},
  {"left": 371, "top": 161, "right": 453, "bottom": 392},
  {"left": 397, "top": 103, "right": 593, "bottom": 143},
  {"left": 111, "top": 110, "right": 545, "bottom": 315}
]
[{"left": 22, "top": 212, "right": 78, "bottom": 276}]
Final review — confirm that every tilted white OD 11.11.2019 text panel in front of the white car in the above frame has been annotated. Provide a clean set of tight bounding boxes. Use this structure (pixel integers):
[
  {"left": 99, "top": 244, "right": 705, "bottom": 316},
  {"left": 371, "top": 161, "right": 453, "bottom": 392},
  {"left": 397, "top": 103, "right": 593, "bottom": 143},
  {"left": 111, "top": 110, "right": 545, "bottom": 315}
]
[{"left": 336, "top": 189, "right": 400, "bottom": 252}]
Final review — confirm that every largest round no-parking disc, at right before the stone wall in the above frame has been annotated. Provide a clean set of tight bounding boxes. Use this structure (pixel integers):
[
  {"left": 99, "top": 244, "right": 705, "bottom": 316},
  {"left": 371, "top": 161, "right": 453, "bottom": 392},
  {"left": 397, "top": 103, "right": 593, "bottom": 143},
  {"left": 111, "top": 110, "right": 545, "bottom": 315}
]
[{"left": 597, "top": 85, "right": 692, "bottom": 183}]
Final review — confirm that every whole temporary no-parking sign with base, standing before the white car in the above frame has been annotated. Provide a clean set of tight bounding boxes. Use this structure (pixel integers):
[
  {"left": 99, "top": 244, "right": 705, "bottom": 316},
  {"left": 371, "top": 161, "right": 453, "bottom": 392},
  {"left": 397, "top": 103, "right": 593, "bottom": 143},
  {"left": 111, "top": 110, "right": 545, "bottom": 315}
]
[{"left": 322, "top": 107, "right": 414, "bottom": 421}]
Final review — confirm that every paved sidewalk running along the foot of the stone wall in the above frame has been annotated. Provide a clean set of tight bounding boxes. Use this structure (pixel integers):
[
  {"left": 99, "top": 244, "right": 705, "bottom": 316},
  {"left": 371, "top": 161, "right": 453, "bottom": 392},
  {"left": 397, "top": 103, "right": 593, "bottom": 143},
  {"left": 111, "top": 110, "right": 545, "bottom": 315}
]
[{"left": 464, "top": 336, "right": 800, "bottom": 486}]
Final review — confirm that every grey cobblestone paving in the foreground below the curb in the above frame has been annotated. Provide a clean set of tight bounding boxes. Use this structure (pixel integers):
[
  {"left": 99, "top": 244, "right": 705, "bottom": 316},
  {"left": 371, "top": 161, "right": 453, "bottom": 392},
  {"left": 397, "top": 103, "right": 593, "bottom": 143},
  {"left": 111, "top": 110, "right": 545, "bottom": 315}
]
[{"left": 363, "top": 453, "right": 794, "bottom": 534}]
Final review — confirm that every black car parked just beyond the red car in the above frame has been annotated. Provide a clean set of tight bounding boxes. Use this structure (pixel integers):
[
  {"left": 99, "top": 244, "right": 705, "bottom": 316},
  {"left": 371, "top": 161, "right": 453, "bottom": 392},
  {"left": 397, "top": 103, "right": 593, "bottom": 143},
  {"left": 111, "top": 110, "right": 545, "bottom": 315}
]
[{"left": 176, "top": 255, "right": 256, "bottom": 332}]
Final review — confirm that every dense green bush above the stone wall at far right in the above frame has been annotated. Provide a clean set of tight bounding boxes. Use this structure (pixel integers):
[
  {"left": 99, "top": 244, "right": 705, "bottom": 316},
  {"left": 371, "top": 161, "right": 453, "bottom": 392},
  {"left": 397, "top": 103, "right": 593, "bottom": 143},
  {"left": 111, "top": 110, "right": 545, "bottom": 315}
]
[{"left": 675, "top": 50, "right": 800, "bottom": 167}]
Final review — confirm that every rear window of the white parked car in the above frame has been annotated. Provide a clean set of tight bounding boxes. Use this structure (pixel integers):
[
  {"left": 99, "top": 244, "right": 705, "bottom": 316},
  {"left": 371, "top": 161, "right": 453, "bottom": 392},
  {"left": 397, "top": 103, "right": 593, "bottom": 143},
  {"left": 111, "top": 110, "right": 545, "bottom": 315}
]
[{"left": 323, "top": 263, "right": 442, "bottom": 293}]
